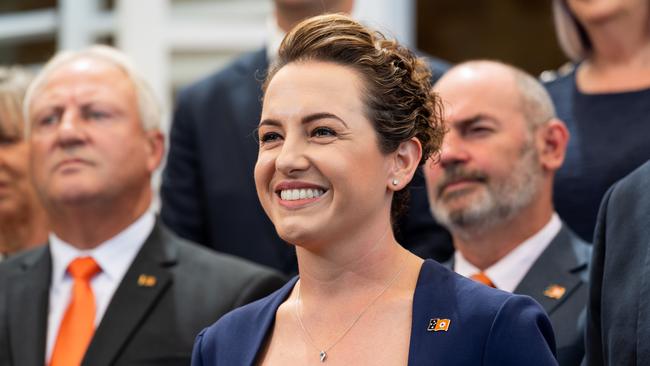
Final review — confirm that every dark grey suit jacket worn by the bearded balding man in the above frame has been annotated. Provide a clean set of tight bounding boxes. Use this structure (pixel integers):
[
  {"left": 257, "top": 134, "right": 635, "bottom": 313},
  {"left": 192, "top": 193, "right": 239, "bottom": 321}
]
[{"left": 448, "top": 224, "right": 591, "bottom": 366}]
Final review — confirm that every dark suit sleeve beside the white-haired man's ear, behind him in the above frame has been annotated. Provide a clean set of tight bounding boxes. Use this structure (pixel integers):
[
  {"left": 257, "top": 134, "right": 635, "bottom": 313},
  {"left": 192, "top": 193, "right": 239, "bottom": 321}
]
[{"left": 160, "top": 90, "right": 208, "bottom": 245}]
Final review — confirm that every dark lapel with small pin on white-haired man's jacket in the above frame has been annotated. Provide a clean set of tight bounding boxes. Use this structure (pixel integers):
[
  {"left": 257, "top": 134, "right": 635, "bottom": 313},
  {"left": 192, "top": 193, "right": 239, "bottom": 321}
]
[{"left": 83, "top": 223, "right": 177, "bottom": 366}]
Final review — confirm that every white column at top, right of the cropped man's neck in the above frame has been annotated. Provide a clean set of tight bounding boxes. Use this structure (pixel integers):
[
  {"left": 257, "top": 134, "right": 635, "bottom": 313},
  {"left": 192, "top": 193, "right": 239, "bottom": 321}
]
[{"left": 353, "top": 0, "right": 416, "bottom": 47}]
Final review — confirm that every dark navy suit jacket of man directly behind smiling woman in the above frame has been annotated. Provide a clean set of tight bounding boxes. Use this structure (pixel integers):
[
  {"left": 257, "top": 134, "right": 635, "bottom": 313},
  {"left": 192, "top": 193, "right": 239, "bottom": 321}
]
[{"left": 161, "top": 49, "right": 453, "bottom": 273}]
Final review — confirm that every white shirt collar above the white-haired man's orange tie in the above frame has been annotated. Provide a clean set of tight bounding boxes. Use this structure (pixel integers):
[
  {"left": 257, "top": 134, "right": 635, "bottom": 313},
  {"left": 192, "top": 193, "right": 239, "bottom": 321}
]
[{"left": 49, "top": 210, "right": 156, "bottom": 283}]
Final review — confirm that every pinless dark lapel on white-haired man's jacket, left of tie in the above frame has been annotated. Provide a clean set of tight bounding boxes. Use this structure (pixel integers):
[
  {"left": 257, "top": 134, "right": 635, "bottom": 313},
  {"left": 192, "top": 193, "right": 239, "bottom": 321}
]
[{"left": 7, "top": 246, "right": 52, "bottom": 366}]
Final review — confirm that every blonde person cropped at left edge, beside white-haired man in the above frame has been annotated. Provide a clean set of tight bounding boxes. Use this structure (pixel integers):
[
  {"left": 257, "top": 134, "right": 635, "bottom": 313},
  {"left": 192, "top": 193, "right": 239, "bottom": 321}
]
[{"left": 0, "top": 67, "right": 48, "bottom": 260}]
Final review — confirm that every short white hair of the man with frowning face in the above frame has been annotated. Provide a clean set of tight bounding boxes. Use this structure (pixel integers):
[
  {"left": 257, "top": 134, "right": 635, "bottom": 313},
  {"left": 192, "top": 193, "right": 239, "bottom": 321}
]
[{"left": 23, "top": 45, "right": 162, "bottom": 135}]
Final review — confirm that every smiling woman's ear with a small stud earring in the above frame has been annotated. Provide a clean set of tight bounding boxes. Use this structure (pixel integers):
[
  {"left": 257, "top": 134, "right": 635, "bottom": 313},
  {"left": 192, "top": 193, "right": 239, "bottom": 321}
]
[{"left": 386, "top": 137, "right": 422, "bottom": 191}]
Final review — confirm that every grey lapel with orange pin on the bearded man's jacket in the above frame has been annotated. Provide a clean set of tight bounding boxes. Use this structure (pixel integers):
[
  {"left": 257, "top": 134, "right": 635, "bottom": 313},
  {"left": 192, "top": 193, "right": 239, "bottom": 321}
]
[{"left": 514, "top": 225, "right": 590, "bottom": 315}]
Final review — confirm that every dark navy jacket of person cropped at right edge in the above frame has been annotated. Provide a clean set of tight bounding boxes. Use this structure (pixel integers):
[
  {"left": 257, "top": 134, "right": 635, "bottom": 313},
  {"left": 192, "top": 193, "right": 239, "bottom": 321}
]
[{"left": 587, "top": 162, "right": 650, "bottom": 366}]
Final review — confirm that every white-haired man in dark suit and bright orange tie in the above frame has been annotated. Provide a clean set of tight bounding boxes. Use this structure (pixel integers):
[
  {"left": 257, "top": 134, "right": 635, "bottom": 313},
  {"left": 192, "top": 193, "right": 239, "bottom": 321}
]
[{"left": 0, "top": 46, "right": 284, "bottom": 366}]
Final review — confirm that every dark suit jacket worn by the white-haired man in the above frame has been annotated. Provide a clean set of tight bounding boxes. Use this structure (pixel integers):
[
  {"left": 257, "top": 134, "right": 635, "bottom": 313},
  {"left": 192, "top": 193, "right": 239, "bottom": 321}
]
[{"left": 0, "top": 224, "right": 284, "bottom": 366}]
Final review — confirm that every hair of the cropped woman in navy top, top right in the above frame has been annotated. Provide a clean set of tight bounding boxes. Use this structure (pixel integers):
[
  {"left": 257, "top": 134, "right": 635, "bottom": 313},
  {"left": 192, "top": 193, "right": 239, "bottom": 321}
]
[{"left": 553, "top": 0, "right": 592, "bottom": 62}]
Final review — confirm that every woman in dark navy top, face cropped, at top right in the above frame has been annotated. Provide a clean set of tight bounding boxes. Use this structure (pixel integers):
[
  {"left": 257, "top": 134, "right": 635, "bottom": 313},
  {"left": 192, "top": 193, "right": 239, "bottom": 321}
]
[{"left": 542, "top": 0, "right": 650, "bottom": 241}]
